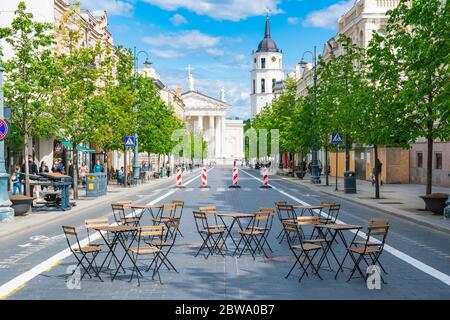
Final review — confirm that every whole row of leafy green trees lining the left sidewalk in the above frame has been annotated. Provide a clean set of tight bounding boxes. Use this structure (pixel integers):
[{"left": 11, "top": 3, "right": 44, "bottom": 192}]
[{"left": 0, "top": 2, "right": 183, "bottom": 199}]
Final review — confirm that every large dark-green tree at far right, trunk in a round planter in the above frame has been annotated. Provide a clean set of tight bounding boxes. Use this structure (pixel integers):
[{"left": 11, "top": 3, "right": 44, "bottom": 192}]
[{"left": 370, "top": 0, "right": 450, "bottom": 194}]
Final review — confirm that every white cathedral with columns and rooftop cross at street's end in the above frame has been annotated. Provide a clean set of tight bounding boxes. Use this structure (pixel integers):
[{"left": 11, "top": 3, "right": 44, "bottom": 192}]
[{"left": 182, "top": 66, "right": 244, "bottom": 164}]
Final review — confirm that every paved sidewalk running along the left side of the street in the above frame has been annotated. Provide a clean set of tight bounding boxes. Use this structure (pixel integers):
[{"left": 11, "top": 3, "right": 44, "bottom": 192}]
[{"left": 0, "top": 169, "right": 199, "bottom": 239}]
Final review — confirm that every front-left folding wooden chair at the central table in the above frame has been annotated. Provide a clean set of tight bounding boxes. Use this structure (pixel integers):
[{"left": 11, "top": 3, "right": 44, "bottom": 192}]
[{"left": 193, "top": 211, "right": 225, "bottom": 259}]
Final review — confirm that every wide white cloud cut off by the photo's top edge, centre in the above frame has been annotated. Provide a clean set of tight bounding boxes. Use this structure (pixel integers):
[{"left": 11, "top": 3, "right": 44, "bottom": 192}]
[{"left": 143, "top": 0, "right": 282, "bottom": 21}]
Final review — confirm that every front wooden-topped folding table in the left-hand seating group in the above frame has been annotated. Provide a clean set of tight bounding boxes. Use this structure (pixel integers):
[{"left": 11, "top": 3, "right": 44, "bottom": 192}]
[{"left": 93, "top": 225, "right": 140, "bottom": 281}]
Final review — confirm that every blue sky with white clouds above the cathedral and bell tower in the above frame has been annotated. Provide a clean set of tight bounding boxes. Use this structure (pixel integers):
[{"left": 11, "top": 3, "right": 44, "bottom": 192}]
[{"left": 80, "top": 0, "right": 355, "bottom": 119}]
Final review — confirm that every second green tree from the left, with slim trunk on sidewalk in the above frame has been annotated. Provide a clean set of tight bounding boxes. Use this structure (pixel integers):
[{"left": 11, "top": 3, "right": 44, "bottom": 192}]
[{"left": 52, "top": 5, "right": 101, "bottom": 199}]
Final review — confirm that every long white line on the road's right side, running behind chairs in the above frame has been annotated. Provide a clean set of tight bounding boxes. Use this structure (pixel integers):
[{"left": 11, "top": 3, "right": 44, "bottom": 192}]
[{"left": 241, "top": 170, "right": 450, "bottom": 286}]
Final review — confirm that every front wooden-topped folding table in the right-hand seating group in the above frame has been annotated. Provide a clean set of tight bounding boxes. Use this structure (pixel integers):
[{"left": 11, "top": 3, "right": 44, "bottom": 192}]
[{"left": 315, "top": 224, "right": 363, "bottom": 279}]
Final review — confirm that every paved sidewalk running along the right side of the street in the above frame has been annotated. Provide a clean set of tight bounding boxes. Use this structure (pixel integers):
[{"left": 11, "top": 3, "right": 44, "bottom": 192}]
[{"left": 278, "top": 175, "right": 450, "bottom": 233}]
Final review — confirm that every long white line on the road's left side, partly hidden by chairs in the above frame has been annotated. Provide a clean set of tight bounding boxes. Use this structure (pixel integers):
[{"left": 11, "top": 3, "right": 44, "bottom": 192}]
[{"left": 0, "top": 169, "right": 208, "bottom": 297}]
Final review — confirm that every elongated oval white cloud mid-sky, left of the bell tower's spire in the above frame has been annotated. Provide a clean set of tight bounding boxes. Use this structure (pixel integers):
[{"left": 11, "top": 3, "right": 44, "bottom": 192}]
[{"left": 142, "top": 30, "right": 220, "bottom": 50}]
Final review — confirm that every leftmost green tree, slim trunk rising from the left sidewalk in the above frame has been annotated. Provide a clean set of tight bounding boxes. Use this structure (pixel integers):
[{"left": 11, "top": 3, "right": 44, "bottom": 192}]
[{"left": 0, "top": 2, "right": 55, "bottom": 195}]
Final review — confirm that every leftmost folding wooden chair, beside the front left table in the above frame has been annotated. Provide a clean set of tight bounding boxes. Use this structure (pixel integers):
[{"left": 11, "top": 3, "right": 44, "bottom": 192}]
[{"left": 62, "top": 226, "right": 103, "bottom": 281}]
